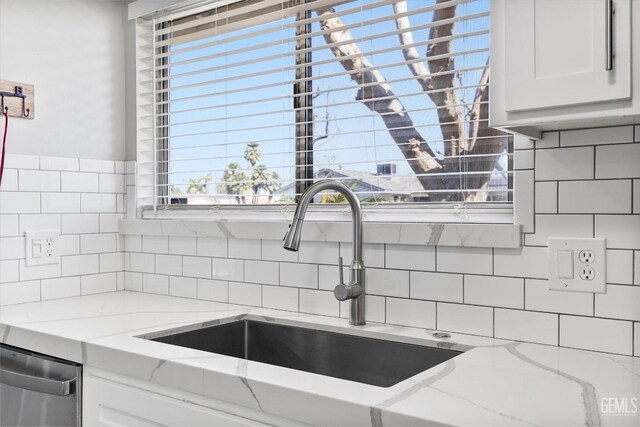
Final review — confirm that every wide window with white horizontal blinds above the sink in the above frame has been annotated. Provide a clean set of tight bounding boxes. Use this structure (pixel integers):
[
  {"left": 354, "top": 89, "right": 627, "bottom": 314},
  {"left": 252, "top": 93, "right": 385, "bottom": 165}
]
[{"left": 137, "top": 0, "right": 512, "bottom": 211}]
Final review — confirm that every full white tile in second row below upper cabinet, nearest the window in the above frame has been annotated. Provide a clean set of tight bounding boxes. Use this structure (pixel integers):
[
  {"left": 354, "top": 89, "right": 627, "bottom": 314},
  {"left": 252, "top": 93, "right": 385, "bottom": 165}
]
[{"left": 536, "top": 147, "right": 606, "bottom": 181}]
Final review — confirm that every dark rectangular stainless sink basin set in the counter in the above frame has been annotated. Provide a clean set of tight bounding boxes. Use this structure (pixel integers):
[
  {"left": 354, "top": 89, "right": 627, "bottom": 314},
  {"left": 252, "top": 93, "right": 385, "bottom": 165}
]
[{"left": 149, "top": 319, "right": 461, "bottom": 387}]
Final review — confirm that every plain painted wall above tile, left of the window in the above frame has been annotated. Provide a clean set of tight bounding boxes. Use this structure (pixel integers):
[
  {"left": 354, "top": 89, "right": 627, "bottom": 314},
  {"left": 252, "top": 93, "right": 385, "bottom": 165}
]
[{"left": 0, "top": 0, "right": 126, "bottom": 160}]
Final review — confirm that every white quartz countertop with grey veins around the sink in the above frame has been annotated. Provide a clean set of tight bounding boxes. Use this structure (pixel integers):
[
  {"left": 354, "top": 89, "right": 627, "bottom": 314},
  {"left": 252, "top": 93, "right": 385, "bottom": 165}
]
[{"left": 0, "top": 292, "right": 640, "bottom": 426}]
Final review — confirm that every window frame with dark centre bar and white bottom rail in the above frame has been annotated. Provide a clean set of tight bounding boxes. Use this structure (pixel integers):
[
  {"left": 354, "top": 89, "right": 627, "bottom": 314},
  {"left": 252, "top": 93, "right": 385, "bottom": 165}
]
[{"left": 136, "top": 0, "right": 515, "bottom": 224}]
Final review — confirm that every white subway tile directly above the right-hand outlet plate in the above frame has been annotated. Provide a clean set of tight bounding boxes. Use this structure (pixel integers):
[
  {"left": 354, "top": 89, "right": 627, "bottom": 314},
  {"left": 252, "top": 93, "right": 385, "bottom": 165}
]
[{"left": 524, "top": 215, "right": 593, "bottom": 246}]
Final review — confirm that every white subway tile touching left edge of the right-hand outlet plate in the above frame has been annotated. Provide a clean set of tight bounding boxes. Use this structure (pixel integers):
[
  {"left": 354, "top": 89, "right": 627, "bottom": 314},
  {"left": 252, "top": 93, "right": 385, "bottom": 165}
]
[{"left": 494, "top": 246, "right": 549, "bottom": 279}]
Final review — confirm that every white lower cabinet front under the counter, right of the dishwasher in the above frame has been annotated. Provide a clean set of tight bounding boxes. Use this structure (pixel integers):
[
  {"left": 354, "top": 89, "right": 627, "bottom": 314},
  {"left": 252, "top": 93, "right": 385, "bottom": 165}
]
[{"left": 82, "top": 373, "right": 282, "bottom": 427}]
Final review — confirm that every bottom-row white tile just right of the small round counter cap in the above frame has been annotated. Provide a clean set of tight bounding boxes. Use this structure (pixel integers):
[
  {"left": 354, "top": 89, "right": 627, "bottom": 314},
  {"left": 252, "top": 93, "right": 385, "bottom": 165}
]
[{"left": 437, "top": 302, "right": 493, "bottom": 336}]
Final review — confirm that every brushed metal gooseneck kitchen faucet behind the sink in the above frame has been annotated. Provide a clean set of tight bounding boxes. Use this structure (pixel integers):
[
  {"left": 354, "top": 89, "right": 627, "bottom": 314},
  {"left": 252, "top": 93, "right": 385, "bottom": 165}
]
[{"left": 283, "top": 179, "right": 365, "bottom": 326}]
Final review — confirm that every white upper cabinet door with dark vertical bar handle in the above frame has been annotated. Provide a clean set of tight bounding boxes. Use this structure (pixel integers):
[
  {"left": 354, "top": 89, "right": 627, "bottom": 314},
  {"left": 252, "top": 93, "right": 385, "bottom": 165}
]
[{"left": 503, "top": 0, "right": 640, "bottom": 112}]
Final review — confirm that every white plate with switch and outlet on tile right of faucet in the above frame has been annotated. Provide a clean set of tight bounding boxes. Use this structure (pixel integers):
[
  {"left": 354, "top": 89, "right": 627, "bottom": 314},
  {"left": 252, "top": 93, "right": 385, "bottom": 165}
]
[{"left": 549, "top": 238, "right": 607, "bottom": 294}]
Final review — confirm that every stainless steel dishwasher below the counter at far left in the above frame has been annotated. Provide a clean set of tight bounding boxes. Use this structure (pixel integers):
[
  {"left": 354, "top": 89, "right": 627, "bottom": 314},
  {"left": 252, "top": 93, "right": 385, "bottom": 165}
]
[{"left": 0, "top": 344, "right": 82, "bottom": 427}]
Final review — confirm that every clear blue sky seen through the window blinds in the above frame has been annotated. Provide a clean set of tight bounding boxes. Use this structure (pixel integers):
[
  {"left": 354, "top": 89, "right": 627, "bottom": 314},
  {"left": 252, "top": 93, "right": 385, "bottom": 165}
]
[{"left": 160, "top": 0, "right": 500, "bottom": 201}]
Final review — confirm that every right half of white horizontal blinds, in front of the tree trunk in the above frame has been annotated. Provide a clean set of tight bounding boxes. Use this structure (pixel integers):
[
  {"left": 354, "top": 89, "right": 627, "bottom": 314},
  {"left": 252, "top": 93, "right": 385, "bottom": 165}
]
[{"left": 310, "top": 0, "right": 510, "bottom": 202}]
